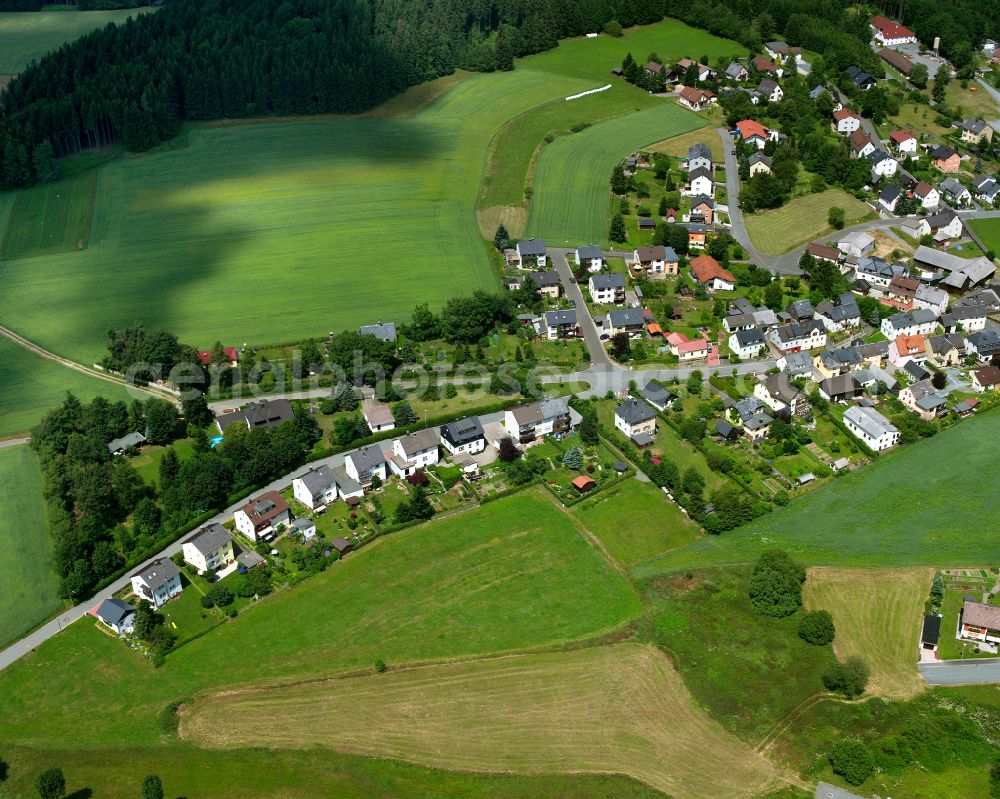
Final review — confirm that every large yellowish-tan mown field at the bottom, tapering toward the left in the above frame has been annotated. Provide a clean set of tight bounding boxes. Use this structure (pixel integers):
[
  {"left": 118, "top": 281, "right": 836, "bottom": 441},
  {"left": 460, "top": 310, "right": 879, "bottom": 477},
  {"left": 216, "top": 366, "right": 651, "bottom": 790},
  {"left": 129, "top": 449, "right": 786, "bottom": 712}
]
[{"left": 180, "top": 644, "right": 778, "bottom": 799}]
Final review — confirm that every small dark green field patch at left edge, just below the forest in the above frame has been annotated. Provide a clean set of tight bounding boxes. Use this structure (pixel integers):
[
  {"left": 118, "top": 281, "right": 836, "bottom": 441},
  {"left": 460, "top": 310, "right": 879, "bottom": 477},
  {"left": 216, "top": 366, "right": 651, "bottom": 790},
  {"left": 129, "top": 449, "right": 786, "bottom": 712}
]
[{"left": 0, "top": 173, "right": 96, "bottom": 260}]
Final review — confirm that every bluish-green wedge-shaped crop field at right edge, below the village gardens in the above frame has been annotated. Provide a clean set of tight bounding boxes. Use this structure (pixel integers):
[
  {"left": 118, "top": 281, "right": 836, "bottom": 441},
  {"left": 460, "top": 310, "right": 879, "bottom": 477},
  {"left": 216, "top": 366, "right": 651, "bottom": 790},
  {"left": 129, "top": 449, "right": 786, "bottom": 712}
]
[{"left": 634, "top": 413, "right": 1000, "bottom": 576}]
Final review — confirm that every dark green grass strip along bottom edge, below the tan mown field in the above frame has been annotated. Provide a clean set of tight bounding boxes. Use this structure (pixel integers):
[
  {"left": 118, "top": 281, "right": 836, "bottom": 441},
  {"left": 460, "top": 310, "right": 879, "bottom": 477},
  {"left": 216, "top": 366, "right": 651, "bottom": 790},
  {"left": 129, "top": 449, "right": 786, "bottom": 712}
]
[{"left": 0, "top": 746, "right": 663, "bottom": 799}]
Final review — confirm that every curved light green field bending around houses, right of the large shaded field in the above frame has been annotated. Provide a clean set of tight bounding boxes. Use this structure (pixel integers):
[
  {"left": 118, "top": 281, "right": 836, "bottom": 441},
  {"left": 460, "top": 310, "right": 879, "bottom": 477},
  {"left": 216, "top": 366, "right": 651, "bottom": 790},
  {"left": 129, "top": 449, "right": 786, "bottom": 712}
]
[{"left": 527, "top": 102, "right": 706, "bottom": 246}]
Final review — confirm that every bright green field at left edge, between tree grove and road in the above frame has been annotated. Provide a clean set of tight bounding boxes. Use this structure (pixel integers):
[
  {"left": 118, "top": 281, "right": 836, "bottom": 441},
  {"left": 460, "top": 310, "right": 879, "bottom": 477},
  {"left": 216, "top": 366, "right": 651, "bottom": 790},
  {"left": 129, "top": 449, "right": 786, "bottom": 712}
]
[{"left": 0, "top": 446, "right": 59, "bottom": 649}]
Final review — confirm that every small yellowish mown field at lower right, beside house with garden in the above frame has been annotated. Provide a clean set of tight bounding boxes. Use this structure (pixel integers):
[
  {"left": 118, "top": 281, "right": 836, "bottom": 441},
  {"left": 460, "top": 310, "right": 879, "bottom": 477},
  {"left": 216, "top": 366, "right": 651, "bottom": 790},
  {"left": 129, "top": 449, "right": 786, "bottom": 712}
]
[{"left": 802, "top": 568, "right": 934, "bottom": 700}]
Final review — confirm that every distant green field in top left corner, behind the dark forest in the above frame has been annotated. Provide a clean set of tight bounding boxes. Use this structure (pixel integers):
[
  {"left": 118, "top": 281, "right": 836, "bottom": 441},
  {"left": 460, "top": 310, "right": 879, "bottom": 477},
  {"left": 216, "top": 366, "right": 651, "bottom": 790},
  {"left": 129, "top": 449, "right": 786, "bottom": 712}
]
[{"left": 0, "top": 8, "right": 149, "bottom": 75}]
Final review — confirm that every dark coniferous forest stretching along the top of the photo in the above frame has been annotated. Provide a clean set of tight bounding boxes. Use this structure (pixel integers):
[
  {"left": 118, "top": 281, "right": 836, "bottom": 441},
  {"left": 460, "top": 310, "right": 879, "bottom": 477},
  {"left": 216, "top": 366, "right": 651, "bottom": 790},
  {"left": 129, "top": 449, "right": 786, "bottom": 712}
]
[{"left": 0, "top": 0, "right": 1000, "bottom": 189}]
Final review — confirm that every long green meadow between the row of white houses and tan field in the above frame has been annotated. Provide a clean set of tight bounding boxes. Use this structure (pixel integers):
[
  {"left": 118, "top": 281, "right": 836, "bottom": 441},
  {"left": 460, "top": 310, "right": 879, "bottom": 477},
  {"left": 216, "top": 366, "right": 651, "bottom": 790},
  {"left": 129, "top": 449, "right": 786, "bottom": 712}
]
[{"left": 0, "top": 490, "right": 641, "bottom": 748}]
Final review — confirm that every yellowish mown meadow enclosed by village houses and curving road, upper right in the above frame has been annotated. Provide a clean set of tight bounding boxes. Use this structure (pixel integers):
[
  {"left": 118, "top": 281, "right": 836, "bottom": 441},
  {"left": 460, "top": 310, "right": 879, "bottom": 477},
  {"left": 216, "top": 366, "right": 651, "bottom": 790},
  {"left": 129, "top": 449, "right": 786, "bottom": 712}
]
[{"left": 743, "top": 189, "right": 875, "bottom": 255}]
